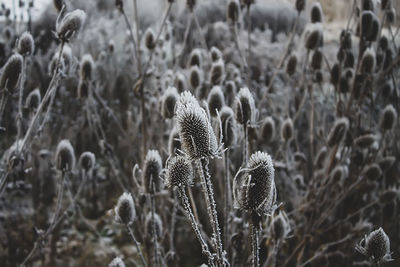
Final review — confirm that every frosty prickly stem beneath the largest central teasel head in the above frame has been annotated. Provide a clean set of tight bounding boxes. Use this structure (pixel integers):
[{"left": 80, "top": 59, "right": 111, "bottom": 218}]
[{"left": 197, "top": 159, "right": 225, "bottom": 266}]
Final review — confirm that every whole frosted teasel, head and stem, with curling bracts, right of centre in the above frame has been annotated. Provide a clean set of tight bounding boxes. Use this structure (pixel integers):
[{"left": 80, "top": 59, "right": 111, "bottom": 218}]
[{"left": 233, "top": 151, "right": 277, "bottom": 266}]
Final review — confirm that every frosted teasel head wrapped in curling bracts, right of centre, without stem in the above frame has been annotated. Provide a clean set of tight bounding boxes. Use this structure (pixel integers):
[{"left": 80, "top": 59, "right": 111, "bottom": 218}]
[{"left": 233, "top": 151, "right": 276, "bottom": 215}]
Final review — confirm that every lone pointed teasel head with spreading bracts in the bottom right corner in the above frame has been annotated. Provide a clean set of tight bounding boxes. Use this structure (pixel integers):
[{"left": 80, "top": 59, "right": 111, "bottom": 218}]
[{"left": 356, "top": 228, "right": 393, "bottom": 263}]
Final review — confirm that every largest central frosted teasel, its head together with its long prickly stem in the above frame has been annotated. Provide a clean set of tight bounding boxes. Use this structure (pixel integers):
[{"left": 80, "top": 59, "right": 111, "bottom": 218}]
[{"left": 175, "top": 91, "right": 227, "bottom": 266}]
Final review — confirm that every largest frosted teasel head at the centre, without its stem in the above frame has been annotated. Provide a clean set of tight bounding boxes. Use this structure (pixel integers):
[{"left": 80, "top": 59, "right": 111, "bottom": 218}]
[{"left": 176, "top": 91, "right": 218, "bottom": 160}]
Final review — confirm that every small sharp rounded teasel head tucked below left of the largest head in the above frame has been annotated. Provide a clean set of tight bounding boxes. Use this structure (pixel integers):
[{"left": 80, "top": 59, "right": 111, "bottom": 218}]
[{"left": 165, "top": 156, "right": 193, "bottom": 187}]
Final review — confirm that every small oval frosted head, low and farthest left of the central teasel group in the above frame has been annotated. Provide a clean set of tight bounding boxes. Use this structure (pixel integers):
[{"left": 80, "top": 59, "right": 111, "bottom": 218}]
[{"left": 114, "top": 192, "right": 136, "bottom": 225}]
